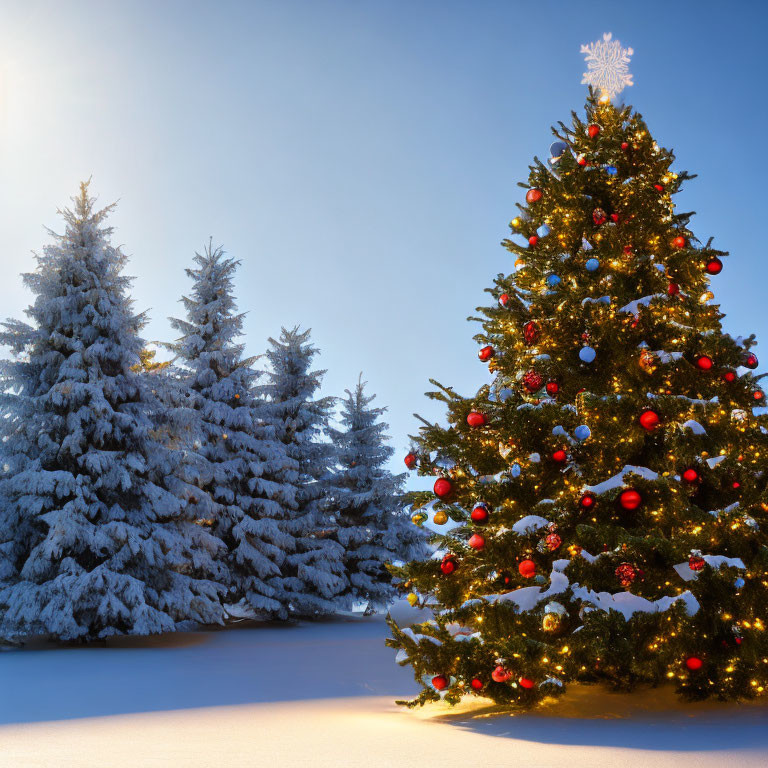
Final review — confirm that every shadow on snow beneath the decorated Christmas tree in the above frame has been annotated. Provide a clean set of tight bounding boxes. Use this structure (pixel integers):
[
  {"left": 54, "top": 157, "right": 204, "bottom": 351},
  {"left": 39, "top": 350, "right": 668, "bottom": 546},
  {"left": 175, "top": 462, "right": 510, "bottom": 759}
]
[{"left": 429, "top": 686, "right": 768, "bottom": 752}]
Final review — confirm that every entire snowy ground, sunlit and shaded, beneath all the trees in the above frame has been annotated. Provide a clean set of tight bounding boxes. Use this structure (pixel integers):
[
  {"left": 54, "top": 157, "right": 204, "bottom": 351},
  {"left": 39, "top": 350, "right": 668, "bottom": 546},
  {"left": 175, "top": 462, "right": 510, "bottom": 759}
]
[{"left": 0, "top": 608, "right": 768, "bottom": 768}]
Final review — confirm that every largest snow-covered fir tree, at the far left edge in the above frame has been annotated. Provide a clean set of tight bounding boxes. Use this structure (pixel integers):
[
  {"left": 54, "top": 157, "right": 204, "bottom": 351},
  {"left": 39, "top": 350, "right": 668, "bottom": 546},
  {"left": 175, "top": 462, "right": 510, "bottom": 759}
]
[{"left": 0, "top": 183, "right": 228, "bottom": 640}]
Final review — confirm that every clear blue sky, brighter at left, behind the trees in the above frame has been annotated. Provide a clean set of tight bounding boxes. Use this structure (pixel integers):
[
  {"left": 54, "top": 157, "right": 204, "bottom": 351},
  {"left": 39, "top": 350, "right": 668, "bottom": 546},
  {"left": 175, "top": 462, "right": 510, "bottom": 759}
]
[{"left": 0, "top": 0, "right": 768, "bottom": 480}]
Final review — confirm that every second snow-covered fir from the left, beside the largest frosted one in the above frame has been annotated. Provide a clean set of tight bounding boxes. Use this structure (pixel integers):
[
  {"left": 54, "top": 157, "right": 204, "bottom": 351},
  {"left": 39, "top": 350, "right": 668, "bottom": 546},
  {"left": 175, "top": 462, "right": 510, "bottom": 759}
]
[{"left": 169, "top": 243, "right": 298, "bottom": 616}]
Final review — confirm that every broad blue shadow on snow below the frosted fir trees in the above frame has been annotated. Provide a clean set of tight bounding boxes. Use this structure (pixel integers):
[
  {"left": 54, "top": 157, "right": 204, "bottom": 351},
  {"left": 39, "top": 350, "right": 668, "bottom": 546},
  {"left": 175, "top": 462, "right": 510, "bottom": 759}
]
[{"left": 0, "top": 616, "right": 417, "bottom": 725}]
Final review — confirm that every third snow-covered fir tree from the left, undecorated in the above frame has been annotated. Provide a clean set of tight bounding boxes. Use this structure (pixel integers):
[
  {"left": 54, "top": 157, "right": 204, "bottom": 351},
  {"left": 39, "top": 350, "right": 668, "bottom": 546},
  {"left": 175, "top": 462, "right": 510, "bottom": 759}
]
[{"left": 258, "top": 327, "right": 347, "bottom": 617}]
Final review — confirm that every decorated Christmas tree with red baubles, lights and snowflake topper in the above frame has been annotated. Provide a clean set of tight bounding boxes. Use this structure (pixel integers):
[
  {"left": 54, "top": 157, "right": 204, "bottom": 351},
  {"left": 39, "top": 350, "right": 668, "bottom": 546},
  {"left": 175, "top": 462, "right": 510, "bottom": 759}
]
[{"left": 389, "top": 36, "right": 768, "bottom": 706}]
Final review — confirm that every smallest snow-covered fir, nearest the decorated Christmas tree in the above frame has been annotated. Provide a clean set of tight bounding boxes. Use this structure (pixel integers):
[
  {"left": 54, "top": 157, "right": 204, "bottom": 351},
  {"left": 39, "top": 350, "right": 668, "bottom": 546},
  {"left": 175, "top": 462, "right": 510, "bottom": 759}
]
[{"left": 328, "top": 374, "right": 426, "bottom": 610}]
